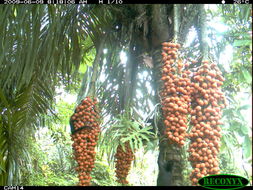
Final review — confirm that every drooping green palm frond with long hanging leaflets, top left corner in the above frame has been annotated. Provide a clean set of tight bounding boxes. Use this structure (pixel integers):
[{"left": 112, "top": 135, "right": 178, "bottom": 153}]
[{"left": 0, "top": 5, "right": 93, "bottom": 94}]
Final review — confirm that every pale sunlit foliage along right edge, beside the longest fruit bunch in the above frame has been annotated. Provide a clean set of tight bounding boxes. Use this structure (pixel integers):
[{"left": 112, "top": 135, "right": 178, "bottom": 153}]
[{"left": 205, "top": 4, "right": 252, "bottom": 181}]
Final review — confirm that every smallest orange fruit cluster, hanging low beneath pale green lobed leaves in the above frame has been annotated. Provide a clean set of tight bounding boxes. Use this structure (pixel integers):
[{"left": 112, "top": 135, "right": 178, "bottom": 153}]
[{"left": 115, "top": 142, "right": 134, "bottom": 185}]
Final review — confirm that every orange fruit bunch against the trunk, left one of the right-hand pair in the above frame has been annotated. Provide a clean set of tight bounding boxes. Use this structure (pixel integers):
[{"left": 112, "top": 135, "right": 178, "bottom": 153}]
[{"left": 160, "top": 42, "right": 191, "bottom": 146}]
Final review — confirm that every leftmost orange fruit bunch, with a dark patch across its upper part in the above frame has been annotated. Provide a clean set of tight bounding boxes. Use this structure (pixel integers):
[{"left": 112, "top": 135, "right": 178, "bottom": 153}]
[{"left": 71, "top": 97, "right": 100, "bottom": 186}]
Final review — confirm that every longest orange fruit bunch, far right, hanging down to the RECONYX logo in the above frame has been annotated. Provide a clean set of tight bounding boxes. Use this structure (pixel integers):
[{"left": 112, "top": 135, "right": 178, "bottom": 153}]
[{"left": 188, "top": 61, "right": 226, "bottom": 185}]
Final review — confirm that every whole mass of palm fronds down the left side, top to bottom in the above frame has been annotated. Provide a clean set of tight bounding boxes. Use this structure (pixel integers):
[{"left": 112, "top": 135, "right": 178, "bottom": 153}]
[{"left": 0, "top": 5, "right": 110, "bottom": 185}]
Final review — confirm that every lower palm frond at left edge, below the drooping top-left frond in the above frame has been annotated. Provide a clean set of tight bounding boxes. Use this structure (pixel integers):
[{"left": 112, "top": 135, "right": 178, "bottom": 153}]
[{"left": 0, "top": 79, "right": 53, "bottom": 185}]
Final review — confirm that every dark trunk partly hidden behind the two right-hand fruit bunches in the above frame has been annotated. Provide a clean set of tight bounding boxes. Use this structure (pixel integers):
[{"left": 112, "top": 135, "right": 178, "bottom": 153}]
[{"left": 152, "top": 5, "right": 183, "bottom": 186}]
